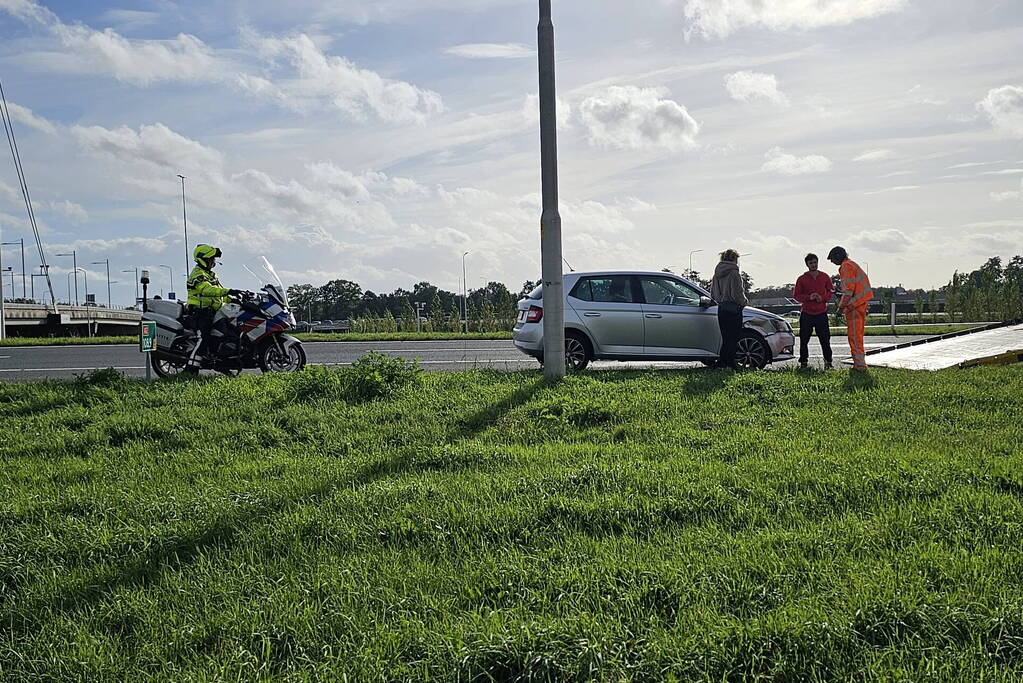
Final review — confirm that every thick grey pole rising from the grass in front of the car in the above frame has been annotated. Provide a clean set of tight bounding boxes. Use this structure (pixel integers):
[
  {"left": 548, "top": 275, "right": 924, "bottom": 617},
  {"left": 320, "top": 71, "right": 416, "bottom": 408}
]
[{"left": 536, "top": 0, "right": 565, "bottom": 381}]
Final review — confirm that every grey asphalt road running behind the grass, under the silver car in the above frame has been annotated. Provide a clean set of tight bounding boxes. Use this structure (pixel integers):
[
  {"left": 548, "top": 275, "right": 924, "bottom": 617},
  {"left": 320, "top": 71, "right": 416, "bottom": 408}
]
[{"left": 0, "top": 336, "right": 921, "bottom": 381}]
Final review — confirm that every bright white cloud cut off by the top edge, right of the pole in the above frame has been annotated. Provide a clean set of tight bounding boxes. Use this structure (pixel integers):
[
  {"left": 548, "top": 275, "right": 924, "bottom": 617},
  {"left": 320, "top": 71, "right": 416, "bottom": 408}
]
[{"left": 684, "top": 0, "right": 906, "bottom": 39}]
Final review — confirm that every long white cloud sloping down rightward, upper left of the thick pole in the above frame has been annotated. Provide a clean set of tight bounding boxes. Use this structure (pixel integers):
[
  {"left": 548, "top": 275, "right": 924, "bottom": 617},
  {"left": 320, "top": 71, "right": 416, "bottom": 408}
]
[{"left": 249, "top": 34, "right": 444, "bottom": 123}]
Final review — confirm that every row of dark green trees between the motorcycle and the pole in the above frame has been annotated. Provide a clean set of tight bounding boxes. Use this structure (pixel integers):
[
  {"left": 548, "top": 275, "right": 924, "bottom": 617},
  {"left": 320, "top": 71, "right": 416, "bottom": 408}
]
[{"left": 287, "top": 279, "right": 537, "bottom": 332}]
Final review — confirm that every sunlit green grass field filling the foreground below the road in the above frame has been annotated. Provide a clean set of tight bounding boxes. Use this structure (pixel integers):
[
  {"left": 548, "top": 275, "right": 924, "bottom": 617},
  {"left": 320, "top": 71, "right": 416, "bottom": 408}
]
[{"left": 0, "top": 362, "right": 1023, "bottom": 681}]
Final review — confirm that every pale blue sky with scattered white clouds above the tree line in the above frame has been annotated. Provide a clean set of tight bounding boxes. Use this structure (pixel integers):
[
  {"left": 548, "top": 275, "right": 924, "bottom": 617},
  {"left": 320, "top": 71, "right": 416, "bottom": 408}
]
[{"left": 0, "top": 0, "right": 1023, "bottom": 304}]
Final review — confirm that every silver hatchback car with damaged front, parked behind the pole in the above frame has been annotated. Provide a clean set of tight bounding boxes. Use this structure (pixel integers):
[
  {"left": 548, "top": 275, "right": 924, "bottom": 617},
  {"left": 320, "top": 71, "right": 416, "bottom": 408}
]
[{"left": 513, "top": 271, "right": 796, "bottom": 370}]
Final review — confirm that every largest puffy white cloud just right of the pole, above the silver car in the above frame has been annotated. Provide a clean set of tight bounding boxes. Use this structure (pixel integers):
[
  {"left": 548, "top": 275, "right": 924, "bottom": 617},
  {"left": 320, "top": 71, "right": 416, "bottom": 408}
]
[{"left": 579, "top": 86, "right": 700, "bottom": 150}]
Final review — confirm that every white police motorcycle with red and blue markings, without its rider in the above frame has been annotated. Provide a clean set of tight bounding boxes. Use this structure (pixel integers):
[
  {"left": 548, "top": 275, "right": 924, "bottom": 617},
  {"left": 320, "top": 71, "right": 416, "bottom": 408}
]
[{"left": 142, "top": 258, "right": 306, "bottom": 377}]
